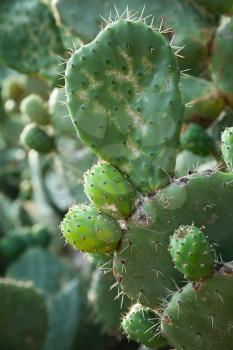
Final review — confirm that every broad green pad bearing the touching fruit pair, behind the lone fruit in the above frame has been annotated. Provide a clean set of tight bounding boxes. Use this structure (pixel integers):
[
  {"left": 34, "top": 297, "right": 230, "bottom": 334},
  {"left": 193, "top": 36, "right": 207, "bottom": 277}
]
[{"left": 113, "top": 170, "right": 233, "bottom": 308}]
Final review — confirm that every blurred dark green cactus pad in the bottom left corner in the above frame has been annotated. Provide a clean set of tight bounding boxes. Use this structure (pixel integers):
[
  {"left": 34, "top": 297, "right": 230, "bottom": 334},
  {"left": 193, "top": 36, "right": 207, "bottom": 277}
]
[{"left": 0, "top": 278, "right": 47, "bottom": 350}]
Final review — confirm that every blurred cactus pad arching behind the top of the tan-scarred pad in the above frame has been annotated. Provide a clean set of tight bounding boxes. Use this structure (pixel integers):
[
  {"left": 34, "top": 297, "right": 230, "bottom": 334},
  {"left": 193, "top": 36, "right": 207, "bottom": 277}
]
[{"left": 52, "top": 0, "right": 213, "bottom": 73}]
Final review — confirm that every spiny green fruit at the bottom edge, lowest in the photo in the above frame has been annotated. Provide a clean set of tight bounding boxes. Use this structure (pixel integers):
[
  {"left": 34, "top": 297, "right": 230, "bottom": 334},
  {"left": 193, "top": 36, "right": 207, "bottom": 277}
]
[{"left": 121, "top": 304, "right": 167, "bottom": 349}]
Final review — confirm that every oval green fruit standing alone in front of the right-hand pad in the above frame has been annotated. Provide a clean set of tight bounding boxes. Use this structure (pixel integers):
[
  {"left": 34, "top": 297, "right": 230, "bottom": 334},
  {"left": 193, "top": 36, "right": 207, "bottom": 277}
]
[{"left": 169, "top": 225, "right": 214, "bottom": 281}]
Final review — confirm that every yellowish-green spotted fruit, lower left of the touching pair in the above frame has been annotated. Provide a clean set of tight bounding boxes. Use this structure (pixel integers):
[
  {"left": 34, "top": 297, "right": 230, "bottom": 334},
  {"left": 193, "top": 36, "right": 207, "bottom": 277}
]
[{"left": 61, "top": 205, "right": 121, "bottom": 253}]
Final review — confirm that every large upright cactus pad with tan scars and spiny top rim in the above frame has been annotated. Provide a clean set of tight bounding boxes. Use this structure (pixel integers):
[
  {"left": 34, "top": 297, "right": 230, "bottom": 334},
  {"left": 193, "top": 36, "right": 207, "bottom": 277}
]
[{"left": 66, "top": 19, "right": 183, "bottom": 192}]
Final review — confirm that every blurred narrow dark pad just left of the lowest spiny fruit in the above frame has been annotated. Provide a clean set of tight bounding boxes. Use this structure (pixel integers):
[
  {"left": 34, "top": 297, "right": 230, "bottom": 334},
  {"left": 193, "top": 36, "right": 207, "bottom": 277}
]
[{"left": 88, "top": 270, "right": 131, "bottom": 334}]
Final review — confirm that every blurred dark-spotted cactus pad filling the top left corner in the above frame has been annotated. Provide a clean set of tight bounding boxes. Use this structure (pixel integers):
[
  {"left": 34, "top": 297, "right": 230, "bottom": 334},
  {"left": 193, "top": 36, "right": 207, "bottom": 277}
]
[{"left": 0, "top": 0, "right": 63, "bottom": 78}]
